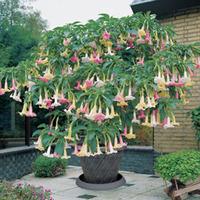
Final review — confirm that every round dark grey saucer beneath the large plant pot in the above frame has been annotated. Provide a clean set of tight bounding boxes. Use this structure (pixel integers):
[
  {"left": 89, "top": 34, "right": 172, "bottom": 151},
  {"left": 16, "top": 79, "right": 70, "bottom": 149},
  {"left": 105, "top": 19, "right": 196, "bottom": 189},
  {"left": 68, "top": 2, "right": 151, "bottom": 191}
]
[{"left": 76, "top": 174, "right": 126, "bottom": 190}]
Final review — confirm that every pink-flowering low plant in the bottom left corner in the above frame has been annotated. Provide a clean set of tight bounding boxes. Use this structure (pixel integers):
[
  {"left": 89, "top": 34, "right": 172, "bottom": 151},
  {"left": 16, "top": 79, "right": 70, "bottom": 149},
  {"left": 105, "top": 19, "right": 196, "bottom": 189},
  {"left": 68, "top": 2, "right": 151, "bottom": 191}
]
[{"left": 0, "top": 182, "right": 53, "bottom": 200}]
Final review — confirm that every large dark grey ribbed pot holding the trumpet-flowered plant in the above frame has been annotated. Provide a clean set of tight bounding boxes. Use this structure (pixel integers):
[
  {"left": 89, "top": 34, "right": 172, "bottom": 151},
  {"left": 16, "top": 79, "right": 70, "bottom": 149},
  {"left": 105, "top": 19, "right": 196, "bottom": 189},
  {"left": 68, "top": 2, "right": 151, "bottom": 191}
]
[{"left": 81, "top": 150, "right": 123, "bottom": 184}]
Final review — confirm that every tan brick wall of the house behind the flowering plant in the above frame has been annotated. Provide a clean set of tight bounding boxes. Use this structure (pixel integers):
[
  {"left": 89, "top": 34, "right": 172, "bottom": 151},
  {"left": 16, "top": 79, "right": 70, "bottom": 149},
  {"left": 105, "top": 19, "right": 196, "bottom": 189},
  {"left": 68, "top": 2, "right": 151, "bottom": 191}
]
[{"left": 154, "top": 8, "right": 200, "bottom": 152}]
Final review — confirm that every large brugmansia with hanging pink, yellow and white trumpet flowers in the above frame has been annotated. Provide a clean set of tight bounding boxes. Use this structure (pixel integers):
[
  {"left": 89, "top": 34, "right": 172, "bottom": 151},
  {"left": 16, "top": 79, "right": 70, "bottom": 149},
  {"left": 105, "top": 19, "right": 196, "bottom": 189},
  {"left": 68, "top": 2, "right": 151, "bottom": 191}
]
[{"left": 0, "top": 13, "right": 200, "bottom": 158}]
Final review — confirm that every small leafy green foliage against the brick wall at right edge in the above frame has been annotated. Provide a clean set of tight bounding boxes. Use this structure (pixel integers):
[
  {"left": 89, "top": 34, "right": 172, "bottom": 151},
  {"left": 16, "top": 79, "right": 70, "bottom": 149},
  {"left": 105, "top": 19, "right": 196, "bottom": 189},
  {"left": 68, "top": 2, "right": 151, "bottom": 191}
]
[{"left": 190, "top": 107, "right": 200, "bottom": 141}]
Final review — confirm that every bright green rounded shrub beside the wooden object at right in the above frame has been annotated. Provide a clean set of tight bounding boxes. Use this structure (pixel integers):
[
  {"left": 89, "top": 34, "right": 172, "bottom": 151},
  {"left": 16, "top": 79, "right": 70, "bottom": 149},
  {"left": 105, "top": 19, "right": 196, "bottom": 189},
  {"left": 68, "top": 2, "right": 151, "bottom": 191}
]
[{"left": 155, "top": 150, "right": 200, "bottom": 183}]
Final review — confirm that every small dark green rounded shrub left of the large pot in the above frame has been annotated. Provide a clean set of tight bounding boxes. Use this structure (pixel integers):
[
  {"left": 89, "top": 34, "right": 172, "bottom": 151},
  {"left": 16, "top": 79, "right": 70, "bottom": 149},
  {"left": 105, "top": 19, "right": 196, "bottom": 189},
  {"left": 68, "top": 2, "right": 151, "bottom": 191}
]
[{"left": 33, "top": 156, "right": 67, "bottom": 177}]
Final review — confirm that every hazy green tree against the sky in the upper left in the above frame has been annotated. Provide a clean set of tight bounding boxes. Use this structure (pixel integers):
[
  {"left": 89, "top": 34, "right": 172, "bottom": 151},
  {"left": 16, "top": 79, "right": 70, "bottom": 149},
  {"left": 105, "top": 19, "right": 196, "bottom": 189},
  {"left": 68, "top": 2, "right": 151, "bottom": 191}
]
[{"left": 0, "top": 0, "right": 47, "bottom": 67}]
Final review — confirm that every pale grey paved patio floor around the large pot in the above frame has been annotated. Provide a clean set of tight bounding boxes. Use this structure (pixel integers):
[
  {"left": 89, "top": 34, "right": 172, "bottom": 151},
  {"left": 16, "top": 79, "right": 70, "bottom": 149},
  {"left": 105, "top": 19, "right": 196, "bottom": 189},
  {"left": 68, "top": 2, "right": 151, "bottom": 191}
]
[{"left": 15, "top": 166, "right": 200, "bottom": 200}]
